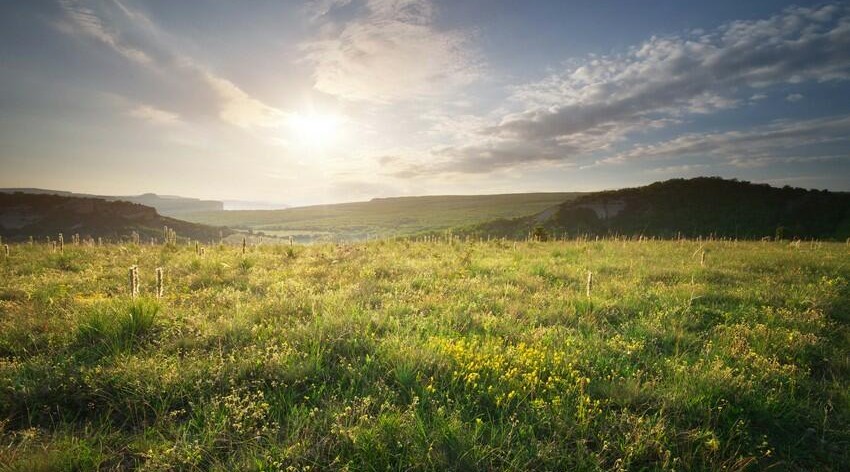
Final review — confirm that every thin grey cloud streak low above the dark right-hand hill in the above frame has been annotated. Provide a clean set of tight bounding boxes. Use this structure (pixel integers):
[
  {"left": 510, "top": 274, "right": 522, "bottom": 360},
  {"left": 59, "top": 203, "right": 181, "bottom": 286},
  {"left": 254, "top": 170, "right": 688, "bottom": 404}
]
[{"left": 601, "top": 116, "right": 850, "bottom": 167}]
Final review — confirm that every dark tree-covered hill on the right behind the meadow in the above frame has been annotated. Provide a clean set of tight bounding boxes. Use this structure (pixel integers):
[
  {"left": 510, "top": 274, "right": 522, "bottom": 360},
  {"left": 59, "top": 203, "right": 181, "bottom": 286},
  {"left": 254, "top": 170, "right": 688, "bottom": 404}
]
[{"left": 468, "top": 177, "right": 850, "bottom": 240}]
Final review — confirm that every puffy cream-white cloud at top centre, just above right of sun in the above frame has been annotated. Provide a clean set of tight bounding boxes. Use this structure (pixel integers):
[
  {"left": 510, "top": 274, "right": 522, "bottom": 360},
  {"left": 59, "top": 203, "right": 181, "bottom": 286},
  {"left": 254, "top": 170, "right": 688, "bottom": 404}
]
[{"left": 302, "top": 0, "right": 480, "bottom": 103}]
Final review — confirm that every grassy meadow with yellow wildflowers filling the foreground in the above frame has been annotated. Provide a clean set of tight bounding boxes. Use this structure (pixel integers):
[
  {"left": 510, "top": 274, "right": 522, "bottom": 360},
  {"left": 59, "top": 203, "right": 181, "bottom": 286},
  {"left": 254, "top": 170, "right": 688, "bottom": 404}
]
[{"left": 0, "top": 241, "right": 850, "bottom": 471}]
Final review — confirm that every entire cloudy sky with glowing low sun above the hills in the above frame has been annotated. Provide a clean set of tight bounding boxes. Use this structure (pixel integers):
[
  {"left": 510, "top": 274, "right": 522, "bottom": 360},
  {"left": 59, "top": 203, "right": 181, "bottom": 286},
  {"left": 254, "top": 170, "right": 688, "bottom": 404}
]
[{"left": 0, "top": 0, "right": 850, "bottom": 205}]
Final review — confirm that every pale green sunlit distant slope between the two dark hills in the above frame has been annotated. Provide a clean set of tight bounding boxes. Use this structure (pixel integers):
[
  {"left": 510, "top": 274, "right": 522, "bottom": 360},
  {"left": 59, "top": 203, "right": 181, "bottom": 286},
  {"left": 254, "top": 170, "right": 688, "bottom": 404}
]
[{"left": 182, "top": 193, "right": 580, "bottom": 242}]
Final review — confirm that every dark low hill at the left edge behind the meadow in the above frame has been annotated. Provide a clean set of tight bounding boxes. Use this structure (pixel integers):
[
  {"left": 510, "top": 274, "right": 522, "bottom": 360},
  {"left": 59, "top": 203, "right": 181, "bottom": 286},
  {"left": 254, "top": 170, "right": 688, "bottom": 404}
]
[{"left": 0, "top": 192, "right": 233, "bottom": 241}]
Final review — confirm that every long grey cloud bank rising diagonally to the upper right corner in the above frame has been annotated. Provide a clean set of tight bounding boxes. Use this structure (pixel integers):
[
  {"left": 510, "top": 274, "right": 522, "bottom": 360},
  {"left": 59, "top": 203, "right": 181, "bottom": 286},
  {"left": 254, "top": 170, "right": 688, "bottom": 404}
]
[{"left": 396, "top": 4, "right": 850, "bottom": 177}]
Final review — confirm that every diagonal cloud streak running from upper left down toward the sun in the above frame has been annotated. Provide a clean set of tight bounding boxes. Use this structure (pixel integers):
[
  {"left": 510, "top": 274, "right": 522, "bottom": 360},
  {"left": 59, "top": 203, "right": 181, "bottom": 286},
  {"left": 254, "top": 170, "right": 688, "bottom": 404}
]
[{"left": 61, "top": 0, "right": 285, "bottom": 129}]
